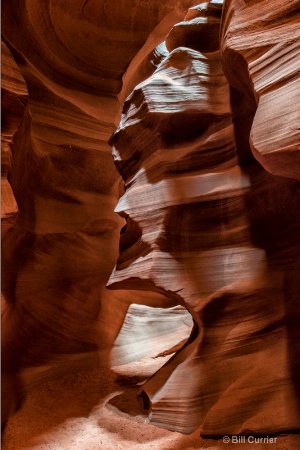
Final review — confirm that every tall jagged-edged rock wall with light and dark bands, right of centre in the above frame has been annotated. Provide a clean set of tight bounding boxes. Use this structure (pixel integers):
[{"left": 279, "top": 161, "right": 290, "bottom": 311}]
[{"left": 108, "top": 1, "right": 300, "bottom": 436}]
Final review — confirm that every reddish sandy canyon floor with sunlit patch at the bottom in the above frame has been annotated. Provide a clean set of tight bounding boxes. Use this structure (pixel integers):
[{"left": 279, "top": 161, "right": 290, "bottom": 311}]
[{"left": 2, "top": 357, "right": 300, "bottom": 450}]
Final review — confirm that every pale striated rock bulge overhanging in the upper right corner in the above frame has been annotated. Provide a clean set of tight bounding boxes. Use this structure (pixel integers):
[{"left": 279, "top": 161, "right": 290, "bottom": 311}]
[{"left": 222, "top": 0, "right": 300, "bottom": 180}]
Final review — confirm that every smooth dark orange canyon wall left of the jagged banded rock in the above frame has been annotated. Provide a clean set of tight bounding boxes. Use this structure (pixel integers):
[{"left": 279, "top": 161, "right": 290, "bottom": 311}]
[{"left": 2, "top": 0, "right": 198, "bottom": 426}]
